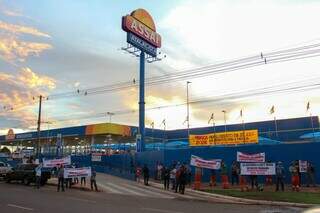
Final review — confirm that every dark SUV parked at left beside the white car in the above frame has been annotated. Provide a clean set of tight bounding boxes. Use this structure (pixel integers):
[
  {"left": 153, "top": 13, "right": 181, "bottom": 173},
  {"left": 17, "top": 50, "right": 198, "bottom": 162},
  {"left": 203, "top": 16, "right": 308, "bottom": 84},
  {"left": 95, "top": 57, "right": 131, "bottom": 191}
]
[{"left": 6, "top": 164, "right": 51, "bottom": 185}]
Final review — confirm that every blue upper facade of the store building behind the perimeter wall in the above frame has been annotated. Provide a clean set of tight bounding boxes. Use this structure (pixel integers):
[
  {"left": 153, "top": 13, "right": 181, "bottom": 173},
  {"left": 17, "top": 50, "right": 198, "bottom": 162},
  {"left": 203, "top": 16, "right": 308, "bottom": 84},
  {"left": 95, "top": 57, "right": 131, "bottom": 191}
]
[{"left": 0, "top": 116, "right": 319, "bottom": 143}]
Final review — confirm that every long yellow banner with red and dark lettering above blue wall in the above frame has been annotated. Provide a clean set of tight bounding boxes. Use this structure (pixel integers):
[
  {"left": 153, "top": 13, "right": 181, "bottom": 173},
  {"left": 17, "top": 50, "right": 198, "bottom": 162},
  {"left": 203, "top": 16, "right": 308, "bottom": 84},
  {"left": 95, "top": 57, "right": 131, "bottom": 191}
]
[{"left": 189, "top": 129, "right": 258, "bottom": 146}]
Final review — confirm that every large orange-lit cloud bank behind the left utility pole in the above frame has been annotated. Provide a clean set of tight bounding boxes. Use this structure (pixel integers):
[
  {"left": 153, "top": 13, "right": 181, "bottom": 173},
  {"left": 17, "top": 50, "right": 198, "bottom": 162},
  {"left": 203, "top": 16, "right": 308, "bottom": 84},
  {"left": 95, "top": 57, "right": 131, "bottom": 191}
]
[{"left": 0, "top": 67, "right": 56, "bottom": 128}]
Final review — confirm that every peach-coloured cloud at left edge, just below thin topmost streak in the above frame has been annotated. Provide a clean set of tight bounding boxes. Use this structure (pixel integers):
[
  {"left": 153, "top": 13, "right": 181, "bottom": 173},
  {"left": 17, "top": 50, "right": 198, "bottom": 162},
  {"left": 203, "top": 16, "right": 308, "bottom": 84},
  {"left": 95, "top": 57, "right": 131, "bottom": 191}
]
[{"left": 0, "top": 37, "right": 52, "bottom": 62}]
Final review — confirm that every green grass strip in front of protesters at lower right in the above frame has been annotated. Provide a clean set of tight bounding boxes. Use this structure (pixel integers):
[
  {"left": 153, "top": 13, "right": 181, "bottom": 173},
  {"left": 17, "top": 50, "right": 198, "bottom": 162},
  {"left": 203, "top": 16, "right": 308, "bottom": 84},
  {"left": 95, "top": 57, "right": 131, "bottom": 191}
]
[{"left": 204, "top": 189, "right": 320, "bottom": 204}]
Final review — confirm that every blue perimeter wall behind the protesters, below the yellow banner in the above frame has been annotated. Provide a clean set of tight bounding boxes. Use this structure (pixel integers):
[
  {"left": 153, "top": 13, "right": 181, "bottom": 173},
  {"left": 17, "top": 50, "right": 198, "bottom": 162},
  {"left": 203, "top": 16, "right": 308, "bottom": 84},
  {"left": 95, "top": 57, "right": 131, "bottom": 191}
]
[{"left": 99, "top": 143, "right": 320, "bottom": 183}]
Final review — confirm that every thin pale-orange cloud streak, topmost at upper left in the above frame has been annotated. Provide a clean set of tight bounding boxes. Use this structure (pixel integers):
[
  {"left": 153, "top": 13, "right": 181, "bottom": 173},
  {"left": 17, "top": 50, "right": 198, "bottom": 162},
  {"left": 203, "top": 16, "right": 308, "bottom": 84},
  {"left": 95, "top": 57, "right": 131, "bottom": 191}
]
[{"left": 0, "top": 21, "right": 50, "bottom": 38}]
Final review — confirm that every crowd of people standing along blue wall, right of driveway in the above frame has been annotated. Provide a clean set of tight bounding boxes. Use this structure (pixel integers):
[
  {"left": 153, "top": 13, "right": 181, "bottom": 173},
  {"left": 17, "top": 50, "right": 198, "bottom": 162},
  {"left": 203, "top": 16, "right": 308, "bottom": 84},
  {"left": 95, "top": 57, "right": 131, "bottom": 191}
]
[{"left": 135, "top": 161, "right": 316, "bottom": 194}]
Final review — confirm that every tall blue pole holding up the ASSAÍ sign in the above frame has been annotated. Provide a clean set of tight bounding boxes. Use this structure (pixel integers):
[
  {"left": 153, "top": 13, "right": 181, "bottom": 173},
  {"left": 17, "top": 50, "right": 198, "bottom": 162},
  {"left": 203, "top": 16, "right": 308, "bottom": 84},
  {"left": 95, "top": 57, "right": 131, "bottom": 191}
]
[{"left": 137, "top": 51, "right": 145, "bottom": 152}]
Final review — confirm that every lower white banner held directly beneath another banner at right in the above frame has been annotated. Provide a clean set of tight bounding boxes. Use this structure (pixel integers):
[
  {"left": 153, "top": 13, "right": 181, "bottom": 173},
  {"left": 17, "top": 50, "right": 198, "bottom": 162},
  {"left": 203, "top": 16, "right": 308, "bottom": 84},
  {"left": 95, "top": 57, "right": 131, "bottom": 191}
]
[{"left": 240, "top": 163, "right": 276, "bottom": 175}]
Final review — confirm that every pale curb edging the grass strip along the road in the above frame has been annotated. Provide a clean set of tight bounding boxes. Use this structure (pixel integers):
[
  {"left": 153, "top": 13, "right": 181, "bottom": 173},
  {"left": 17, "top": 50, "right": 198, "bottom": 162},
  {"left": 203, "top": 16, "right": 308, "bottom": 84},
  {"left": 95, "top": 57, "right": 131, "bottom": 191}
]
[{"left": 151, "top": 182, "right": 319, "bottom": 208}]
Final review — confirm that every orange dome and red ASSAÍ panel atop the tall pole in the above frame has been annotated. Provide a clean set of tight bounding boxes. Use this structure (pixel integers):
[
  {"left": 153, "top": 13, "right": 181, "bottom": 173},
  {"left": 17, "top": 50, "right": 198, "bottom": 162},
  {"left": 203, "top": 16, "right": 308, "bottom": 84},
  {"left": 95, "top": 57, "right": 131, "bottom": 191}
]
[{"left": 122, "top": 9, "right": 161, "bottom": 48}]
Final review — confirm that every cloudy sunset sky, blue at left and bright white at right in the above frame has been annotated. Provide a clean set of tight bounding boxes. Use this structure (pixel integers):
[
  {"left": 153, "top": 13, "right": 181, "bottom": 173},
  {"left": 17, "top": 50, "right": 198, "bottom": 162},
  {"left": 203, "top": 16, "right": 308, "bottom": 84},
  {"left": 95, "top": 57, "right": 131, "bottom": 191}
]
[{"left": 0, "top": 0, "right": 320, "bottom": 134}]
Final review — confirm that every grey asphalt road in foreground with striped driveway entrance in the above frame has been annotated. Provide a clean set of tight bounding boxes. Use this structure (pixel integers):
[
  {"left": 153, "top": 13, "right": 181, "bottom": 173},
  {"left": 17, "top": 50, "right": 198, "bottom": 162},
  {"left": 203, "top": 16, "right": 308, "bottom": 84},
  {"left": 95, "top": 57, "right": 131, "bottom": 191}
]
[{"left": 0, "top": 175, "right": 300, "bottom": 213}]
